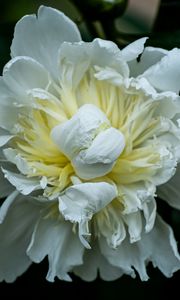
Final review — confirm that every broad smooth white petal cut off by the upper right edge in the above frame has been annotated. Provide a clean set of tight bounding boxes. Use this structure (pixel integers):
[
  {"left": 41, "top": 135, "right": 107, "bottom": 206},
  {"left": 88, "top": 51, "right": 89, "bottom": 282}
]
[{"left": 142, "top": 49, "right": 180, "bottom": 94}]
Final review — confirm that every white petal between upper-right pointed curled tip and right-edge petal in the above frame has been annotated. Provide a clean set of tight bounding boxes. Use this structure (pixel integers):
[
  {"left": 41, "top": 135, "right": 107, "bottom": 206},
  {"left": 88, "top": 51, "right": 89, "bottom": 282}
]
[{"left": 129, "top": 47, "right": 168, "bottom": 77}]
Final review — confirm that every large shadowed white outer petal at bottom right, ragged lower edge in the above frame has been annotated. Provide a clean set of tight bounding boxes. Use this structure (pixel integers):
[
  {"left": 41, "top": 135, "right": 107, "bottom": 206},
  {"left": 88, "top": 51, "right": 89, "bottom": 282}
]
[{"left": 100, "top": 216, "right": 180, "bottom": 280}]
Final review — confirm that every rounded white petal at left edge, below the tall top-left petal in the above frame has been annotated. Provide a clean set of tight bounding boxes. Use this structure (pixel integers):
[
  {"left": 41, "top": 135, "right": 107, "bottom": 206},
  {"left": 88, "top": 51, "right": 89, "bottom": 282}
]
[{"left": 0, "top": 57, "right": 49, "bottom": 106}]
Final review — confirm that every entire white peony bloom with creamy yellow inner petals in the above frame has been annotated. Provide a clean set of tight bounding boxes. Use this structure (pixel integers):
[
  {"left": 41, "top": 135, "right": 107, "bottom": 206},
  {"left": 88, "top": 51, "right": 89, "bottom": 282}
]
[{"left": 0, "top": 7, "right": 180, "bottom": 282}]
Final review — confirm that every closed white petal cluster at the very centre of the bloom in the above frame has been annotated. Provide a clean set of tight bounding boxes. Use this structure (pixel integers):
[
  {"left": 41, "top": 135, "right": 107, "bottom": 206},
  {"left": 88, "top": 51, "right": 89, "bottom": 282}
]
[{"left": 51, "top": 104, "right": 125, "bottom": 180}]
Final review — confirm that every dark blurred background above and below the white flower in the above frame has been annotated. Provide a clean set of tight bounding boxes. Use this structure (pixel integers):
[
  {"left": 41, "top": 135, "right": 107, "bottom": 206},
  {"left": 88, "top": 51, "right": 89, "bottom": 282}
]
[{"left": 0, "top": 0, "right": 180, "bottom": 300}]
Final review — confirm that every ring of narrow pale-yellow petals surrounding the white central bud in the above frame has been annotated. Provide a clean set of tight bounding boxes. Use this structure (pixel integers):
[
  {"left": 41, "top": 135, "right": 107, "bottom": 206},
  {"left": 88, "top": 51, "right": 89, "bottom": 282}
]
[{"left": 12, "top": 75, "right": 162, "bottom": 204}]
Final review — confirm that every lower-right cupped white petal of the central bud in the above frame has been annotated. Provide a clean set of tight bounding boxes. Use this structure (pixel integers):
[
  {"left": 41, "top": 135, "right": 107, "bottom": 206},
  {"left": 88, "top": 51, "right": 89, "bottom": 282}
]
[{"left": 72, "top": 127, "right": 125, "bottom": 179}]
